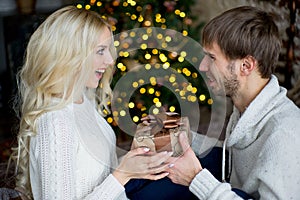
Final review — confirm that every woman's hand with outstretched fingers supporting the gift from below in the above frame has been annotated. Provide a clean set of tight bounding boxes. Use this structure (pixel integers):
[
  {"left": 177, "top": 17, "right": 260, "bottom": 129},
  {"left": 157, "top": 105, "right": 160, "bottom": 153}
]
[{"left": 113, "top": 147, "right": 172, "bottom": 185}]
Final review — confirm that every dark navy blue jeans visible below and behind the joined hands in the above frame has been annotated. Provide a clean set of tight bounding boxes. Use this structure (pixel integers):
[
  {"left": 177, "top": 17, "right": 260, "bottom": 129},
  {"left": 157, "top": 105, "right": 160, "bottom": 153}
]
[{"left": 125, "top": 147, "right": 251, "bottom": 200}]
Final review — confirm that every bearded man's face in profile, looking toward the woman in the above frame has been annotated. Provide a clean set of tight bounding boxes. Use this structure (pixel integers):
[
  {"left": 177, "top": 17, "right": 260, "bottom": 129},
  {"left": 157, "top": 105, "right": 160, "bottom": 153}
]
[{"left": 199, "top": 43, "right": 240, "bottom": 97}]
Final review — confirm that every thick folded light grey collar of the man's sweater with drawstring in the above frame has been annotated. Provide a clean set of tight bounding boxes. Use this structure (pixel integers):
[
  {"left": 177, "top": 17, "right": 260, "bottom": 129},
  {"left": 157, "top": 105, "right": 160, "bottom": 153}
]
[{"left": 226, "top": 75, "right": 286, "bottom": 148}]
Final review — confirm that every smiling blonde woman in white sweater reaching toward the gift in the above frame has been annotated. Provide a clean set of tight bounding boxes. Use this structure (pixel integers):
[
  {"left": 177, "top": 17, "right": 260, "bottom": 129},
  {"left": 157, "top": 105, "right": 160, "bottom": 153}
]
[{"left": 13, "top": 6, "right": 171, "bottom": 200}]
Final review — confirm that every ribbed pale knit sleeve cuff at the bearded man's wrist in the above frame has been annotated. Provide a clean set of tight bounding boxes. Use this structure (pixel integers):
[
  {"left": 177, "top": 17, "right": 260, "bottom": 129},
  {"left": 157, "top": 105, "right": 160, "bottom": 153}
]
[{"left": 189, "top": 169, "right": 242, "bottom": 200}]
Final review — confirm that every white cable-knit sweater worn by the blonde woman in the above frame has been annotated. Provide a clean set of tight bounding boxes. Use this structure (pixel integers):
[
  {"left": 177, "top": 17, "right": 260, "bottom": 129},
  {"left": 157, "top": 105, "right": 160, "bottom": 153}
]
[{"left": 30, "top": 98, "right": 127, "bottom": 200}]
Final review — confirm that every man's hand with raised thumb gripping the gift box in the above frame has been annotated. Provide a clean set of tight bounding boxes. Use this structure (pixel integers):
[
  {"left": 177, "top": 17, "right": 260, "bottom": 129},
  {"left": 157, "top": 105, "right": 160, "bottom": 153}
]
[{"left": 168, "top": 134, "right": 202, "bottom": 186}]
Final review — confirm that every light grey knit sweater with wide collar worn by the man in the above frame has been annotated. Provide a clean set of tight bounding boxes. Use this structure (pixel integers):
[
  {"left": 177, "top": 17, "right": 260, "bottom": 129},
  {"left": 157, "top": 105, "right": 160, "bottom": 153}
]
[{"left": 190, "top": 76, "right": 300, "bottom": 200}]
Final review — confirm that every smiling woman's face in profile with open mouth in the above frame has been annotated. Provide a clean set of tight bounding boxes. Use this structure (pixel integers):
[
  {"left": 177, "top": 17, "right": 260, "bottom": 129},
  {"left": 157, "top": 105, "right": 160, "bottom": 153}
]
[{"left": 86, "top": 28, "right": 114, "bottom": 88}]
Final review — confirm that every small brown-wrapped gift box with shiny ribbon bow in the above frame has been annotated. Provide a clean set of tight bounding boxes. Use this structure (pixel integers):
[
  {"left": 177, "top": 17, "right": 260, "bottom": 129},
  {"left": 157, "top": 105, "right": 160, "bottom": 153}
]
[{"left": 133, "top": 112, "right": 191, "bottom": 157}]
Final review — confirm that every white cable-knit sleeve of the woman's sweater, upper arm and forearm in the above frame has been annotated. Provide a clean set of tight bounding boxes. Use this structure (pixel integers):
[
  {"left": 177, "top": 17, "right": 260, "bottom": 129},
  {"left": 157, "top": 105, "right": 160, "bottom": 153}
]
[{"left": 30, "top": 111, "right": 127, "bottom": 199}]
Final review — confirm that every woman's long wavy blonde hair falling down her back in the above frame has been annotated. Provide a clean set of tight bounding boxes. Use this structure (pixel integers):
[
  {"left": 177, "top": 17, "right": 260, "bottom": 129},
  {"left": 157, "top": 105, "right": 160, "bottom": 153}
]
[{"left": 11, "top": 6, "right": 115, "bottom": 198}]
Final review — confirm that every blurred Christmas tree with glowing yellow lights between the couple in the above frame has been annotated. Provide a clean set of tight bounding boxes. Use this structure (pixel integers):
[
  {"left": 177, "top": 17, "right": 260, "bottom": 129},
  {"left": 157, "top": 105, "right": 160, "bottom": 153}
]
[{"left": 77, "top": 0, "right": 213, "bottom": 141}]
